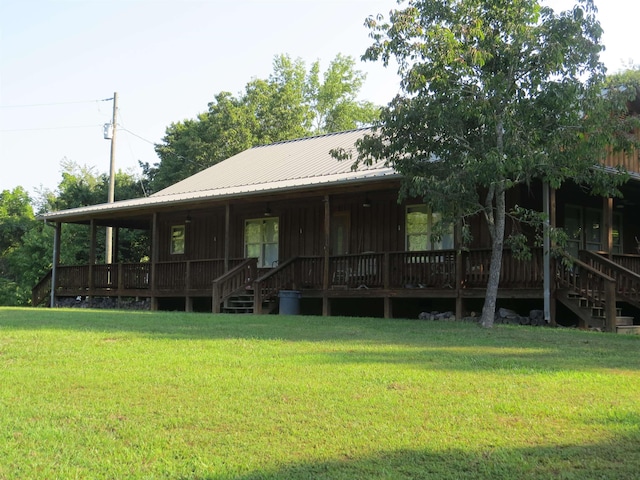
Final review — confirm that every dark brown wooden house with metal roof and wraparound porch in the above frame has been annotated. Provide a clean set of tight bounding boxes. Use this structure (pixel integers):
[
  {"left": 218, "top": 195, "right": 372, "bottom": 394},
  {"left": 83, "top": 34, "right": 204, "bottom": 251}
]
[{"left": 33, "top": 129, "right": 640, "bottom": 330}]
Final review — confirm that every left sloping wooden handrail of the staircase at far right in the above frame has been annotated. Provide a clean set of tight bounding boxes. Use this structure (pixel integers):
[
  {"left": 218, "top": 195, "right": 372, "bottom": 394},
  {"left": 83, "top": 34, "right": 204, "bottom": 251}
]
[{"left": 557, "top": 252, "right": 617, "bottom": 332}]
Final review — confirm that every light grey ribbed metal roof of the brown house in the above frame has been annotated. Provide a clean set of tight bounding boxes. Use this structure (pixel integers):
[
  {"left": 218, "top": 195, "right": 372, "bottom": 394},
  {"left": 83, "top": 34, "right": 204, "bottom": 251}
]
[{"left": 43, "top": 128, "right": 397, "bottom": 221}]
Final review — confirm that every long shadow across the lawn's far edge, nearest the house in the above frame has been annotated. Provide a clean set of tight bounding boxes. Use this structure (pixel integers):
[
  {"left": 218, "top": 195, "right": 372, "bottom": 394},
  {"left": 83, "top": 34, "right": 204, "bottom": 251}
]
[{"left": 0, "top": 308, "right": 640, "bottom": 373}]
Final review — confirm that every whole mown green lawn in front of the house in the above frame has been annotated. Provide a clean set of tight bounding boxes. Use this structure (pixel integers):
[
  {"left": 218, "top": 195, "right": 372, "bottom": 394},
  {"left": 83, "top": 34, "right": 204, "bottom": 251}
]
[{"left": 0, "top": 308, "right": 640, "bottom": 480}]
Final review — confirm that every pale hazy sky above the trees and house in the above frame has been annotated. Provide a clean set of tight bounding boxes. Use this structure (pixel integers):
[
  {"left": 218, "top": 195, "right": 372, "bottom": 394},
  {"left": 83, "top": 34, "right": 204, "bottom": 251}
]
[{"left": 0, "top": 0, "right": 640, "bottom": 200}]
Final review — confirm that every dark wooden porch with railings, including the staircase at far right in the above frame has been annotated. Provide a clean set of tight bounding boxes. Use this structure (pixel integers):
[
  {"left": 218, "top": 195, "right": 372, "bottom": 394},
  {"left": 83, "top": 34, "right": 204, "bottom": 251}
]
[{"left": 33, "top": 249, "right": 640, "bottom": 332}]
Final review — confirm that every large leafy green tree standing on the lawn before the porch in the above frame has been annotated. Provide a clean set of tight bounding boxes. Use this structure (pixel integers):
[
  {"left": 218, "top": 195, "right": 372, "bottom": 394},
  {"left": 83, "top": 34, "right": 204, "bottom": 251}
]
[{"left": 344, "top": 0, "right": 626, "bottom": 327}]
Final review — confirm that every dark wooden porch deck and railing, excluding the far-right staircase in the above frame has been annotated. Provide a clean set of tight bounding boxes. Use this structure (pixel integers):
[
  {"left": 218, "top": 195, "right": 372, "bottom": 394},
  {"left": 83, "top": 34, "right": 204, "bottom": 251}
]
[{"left": 32, "top": 249, "right": 543, "bottom": 317}]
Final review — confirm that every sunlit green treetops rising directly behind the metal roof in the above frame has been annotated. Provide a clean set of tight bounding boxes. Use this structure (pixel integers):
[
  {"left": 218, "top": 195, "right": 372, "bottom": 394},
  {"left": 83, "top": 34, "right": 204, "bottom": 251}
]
[{"left": 149, "top": 55, "right": 378, "bottom": 192}]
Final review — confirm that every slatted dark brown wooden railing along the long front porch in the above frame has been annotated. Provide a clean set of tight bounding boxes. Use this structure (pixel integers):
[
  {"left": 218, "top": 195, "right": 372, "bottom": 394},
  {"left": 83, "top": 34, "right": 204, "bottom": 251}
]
[{"left": 33, "top": 249, "right": 543, "bottom": 308}]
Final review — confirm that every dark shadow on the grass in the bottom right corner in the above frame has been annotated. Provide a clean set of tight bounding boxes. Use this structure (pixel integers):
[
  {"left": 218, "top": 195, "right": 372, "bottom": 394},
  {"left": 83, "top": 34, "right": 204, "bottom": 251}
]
[{"left": 195, "top": 428, "right": 640, "bottom": 480}]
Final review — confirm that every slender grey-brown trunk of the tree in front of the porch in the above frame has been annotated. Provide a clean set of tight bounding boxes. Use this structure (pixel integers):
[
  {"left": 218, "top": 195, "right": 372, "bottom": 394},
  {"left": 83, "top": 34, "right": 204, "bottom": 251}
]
[{"left": 480, "top": 188, "right": 507, "bottom": 328}]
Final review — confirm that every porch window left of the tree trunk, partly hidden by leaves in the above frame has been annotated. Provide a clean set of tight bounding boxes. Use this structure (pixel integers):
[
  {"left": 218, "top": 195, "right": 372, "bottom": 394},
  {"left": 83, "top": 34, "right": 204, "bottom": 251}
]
[{"left": 406, "top": 205, "right": 453, "bottom": 252}]
